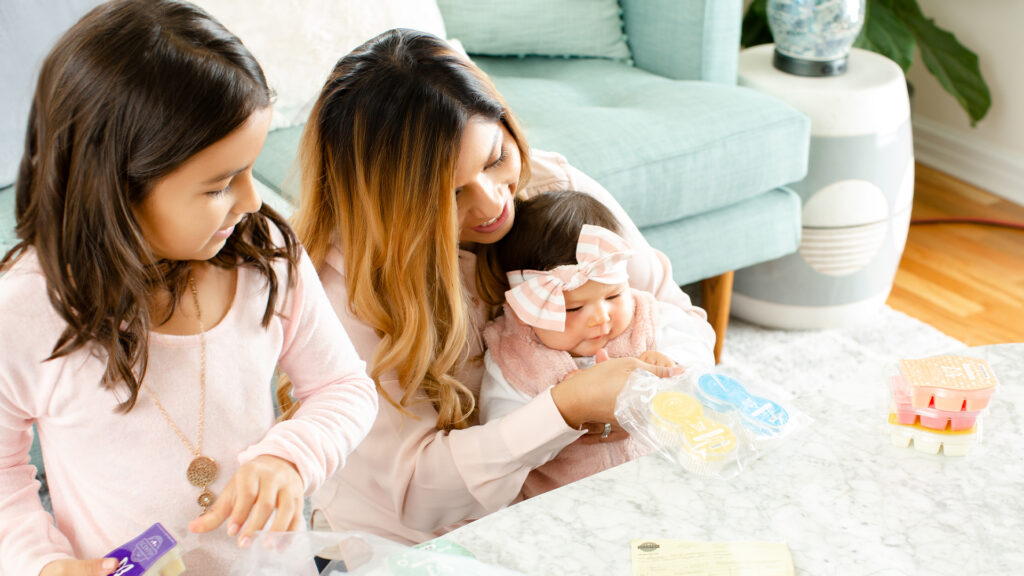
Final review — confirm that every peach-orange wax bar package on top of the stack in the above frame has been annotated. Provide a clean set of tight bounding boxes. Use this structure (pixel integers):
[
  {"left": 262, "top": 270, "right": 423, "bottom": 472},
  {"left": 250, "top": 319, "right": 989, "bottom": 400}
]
[{"left": 899, "top": 356, "right": 997, "bottom": 412}]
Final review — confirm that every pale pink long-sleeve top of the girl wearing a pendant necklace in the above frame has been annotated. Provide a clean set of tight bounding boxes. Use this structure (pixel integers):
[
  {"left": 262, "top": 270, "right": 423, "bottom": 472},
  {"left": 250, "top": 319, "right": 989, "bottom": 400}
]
[{"left": 0, "top": 243, "right": 377, "bottom": 576}]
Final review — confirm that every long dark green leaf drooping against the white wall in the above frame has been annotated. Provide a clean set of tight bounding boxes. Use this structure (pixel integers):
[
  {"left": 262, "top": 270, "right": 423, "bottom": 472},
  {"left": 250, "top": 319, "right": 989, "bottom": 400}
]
[{"left": 893, "top": 0, "right": 992, "bottom": 126}]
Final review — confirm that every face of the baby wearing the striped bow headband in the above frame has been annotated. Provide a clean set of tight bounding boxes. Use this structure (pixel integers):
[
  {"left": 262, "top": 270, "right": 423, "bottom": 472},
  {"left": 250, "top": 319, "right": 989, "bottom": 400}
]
[{"left": 534, "top": 280, "right": 634, "bottom": 357}]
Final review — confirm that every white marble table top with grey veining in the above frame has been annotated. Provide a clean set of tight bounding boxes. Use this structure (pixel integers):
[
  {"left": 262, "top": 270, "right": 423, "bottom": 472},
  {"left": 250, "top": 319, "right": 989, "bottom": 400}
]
[{"left": 446, "top": 344, "right": 1024, "bottom": 576}]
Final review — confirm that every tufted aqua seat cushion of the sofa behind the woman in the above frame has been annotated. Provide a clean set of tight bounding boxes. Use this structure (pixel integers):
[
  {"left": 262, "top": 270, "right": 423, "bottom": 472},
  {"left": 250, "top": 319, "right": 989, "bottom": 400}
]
[{"left": 474, "top": 57, "right": 809, "bottom": 229}]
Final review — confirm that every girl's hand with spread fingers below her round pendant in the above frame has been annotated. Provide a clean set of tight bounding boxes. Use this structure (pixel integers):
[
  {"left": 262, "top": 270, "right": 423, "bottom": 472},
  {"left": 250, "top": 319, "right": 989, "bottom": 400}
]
[{"left": 188, "top": 454, "right": 303, "bottom": 547}]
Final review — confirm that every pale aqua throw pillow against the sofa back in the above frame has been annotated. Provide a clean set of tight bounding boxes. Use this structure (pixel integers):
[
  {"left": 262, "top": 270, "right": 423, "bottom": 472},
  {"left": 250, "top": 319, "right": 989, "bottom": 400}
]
[{"left": 437, "top": 0, "right": 630, "bottom": 59}]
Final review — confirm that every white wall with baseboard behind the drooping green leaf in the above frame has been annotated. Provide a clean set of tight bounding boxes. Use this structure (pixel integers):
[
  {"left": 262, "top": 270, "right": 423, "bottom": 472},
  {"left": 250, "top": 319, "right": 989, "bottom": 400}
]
[{"left": 908, "top": 0, "right": 1024, "bottom": 204}]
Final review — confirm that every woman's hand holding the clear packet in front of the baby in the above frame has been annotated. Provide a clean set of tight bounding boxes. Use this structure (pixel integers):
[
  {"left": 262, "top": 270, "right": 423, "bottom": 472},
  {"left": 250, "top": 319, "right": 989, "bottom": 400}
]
[{"left": 551, "top": 355, "right": 672, "bottom": 430}]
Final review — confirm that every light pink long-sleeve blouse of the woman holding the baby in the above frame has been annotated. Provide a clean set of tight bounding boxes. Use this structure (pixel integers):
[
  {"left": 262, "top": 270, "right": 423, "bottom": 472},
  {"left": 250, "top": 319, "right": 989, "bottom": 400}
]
[{"left": 312, "top": 151, "right": 715, "bottom": 542}]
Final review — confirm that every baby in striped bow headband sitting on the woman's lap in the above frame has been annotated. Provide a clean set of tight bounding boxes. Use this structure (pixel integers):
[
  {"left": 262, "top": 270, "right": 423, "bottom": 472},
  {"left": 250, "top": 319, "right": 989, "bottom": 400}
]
[{"left": 480, "top": 192, "right": 715, "bottom": 497}]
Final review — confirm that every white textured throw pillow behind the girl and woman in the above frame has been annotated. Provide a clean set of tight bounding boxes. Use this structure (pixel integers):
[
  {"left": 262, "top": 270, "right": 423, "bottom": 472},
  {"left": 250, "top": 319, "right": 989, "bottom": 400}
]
[{"left": 196, "top": 0, "right": 446, "bottom": 129}]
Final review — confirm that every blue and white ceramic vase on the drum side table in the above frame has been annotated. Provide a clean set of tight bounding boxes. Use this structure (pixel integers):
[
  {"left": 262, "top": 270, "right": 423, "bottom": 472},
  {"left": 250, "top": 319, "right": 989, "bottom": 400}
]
[{"left": 768, "top": 0, "right": 865, "bottom": 76}]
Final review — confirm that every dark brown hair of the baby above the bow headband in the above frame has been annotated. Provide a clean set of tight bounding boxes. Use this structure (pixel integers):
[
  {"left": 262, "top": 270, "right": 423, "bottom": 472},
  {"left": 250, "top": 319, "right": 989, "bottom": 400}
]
[{"left": 496, "top": 190, "right": 620, "bottom": 272}]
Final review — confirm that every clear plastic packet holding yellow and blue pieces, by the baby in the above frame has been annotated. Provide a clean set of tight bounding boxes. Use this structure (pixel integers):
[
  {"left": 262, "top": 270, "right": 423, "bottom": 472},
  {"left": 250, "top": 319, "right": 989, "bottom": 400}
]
[{"left": 615, "top": 370, "right": 810, "bottom": 479}]
